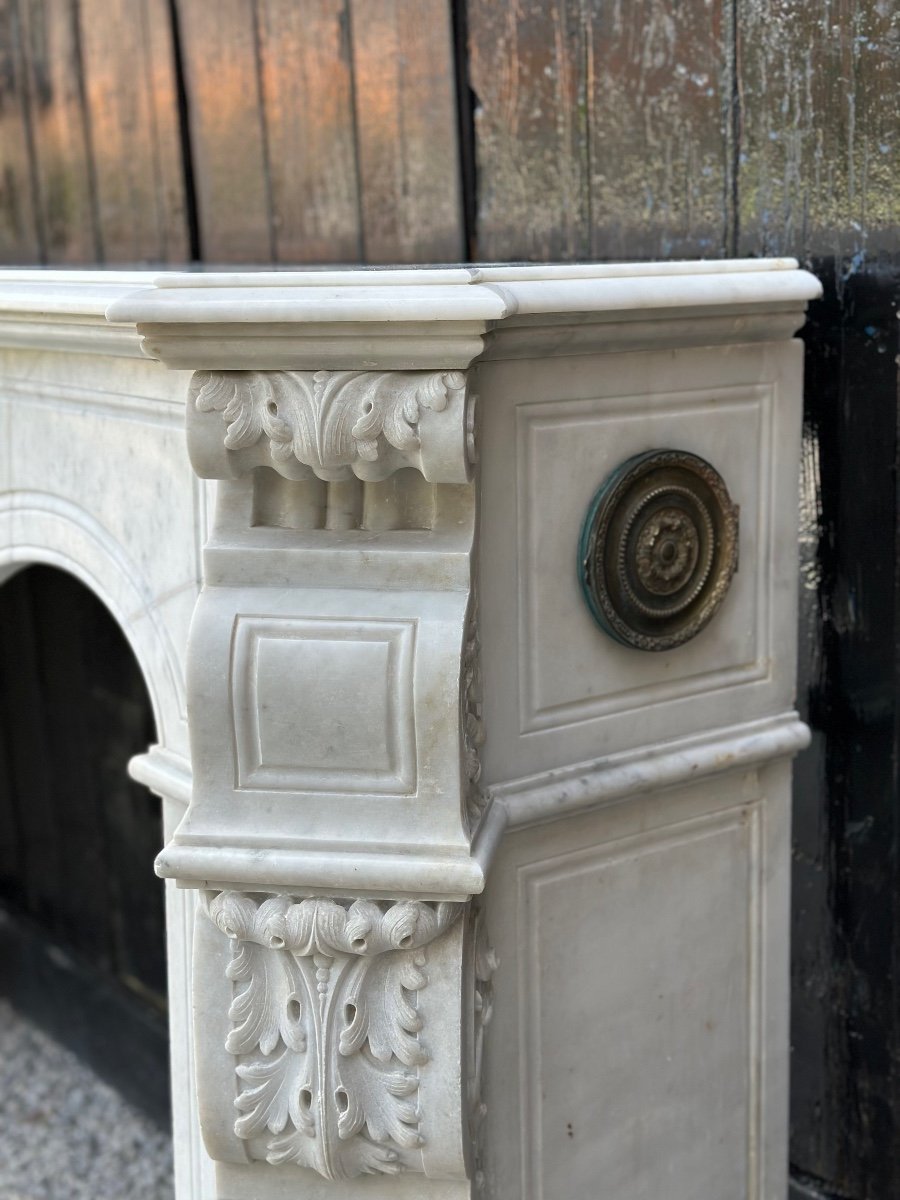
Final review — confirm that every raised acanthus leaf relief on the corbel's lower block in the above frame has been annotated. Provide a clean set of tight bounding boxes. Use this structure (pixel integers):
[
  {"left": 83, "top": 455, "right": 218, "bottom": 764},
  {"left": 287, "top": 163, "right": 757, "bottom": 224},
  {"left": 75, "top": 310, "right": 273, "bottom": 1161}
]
[{"left": 208, "top": 892, "right": 463, "bottom": 1180}]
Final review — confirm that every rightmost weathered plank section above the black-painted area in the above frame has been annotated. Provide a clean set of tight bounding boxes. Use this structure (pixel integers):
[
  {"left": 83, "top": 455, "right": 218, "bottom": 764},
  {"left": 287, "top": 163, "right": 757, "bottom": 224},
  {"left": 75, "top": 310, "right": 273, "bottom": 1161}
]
[{"left": 738, "top": 0, "right": 900, "bottom": 256}]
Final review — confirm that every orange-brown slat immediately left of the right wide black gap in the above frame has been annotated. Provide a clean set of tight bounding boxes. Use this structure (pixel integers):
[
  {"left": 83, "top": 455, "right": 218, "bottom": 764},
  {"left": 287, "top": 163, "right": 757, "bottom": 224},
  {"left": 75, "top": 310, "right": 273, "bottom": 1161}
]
[{"left": 350, "top": 0, "right": 464, "bottom": 263}]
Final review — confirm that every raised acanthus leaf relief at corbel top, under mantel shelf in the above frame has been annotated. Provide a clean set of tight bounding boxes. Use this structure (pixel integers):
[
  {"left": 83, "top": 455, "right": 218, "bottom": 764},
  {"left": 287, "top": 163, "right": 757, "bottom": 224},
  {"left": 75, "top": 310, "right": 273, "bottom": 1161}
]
[{"left": 188, "top": 371, "right": 467, "bottom": 481}]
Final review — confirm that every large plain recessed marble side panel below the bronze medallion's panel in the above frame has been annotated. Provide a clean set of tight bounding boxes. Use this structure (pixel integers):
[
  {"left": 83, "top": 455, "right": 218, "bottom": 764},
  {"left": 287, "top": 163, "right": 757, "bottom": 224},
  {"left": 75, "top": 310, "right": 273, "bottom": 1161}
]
[{"left": 518, "top": 806, "right": 763, "bottom": 1200}]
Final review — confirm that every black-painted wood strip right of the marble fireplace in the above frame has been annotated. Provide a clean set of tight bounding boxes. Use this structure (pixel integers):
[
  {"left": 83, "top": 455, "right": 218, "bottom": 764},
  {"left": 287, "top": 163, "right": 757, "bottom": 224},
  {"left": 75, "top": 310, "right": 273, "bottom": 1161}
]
[{"left": 791, "top": 256, "right": 900, "bottom": 1200}]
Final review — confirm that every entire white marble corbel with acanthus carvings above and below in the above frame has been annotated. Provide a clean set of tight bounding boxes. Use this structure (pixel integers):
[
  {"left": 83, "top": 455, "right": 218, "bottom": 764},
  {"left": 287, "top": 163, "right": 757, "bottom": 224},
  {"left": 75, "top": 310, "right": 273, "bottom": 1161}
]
[{"left": 158, "top": 343, "right": 504, "bottom": 1196}]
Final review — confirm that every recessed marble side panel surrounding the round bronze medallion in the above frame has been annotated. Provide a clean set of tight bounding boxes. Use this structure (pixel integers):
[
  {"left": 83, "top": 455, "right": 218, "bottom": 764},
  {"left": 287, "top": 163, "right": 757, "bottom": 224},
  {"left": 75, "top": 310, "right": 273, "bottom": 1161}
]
[{"left": 516, "top": 385, "right": 773, "bottom": 733}]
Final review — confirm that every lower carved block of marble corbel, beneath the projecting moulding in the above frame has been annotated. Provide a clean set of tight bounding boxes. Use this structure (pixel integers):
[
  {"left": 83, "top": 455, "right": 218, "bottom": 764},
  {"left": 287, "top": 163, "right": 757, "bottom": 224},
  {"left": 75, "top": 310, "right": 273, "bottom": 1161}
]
[{"left": 197, "top": 892, "right": 496, "bottom": 1180}]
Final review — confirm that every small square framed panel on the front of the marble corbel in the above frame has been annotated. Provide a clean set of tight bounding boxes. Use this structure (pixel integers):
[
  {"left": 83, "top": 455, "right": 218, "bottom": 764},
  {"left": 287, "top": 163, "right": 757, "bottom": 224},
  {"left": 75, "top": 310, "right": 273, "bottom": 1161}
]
[{"left": 232, "top": 617, "right": 416, "bottom": 796}]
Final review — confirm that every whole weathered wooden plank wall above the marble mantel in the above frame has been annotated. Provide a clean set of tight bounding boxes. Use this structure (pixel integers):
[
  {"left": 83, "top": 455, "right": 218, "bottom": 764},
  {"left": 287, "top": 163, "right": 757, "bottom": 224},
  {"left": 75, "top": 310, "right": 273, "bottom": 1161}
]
[{"left": 0, "top": 0, "right": 900, "bottom": 264}]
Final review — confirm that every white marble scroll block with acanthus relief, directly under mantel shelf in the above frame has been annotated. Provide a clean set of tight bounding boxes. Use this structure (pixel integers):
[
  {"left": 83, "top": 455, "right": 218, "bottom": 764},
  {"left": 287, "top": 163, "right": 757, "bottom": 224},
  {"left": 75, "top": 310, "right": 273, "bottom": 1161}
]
[{"left": 188, "top": 371, "right": 474, "bottom": 484}]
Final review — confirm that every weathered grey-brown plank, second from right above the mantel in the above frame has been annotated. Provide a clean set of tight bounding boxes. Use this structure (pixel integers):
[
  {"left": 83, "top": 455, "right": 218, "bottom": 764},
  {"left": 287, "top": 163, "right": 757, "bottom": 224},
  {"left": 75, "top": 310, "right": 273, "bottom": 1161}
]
[{"left": 586, "top": 0, "right": 733, "bottom": 259}]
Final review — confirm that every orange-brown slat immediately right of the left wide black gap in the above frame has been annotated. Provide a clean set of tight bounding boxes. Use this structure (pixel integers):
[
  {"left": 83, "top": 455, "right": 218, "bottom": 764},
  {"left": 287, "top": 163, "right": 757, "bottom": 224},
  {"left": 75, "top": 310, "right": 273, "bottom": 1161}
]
[{"left": 175, "top": 0, "right": 275, "bottom": 264}]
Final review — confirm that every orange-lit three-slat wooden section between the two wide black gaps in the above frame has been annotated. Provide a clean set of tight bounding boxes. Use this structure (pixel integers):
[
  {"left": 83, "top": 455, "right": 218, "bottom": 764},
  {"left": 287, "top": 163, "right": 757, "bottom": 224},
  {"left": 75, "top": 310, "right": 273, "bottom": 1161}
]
[{"left": 179, "top": 0, "right": 463, "bottom": 263}]
